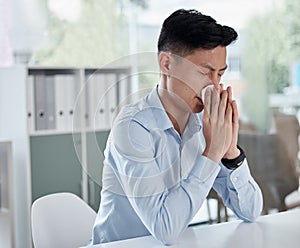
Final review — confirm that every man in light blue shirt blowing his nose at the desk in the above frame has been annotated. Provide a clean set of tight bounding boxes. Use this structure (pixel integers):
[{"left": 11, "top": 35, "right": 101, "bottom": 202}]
[{"left": 92, "top": 9, "right": 262, "bottom": 245}]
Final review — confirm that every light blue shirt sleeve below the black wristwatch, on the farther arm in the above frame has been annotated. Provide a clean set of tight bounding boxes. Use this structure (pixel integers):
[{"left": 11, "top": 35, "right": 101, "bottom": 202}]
[{"left": 213, "top": 159, "right": 263, "bottom": 222}]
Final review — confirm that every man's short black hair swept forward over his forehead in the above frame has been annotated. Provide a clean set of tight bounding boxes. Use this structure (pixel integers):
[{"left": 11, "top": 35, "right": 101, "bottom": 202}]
[{"left": 158, "top": 9, "right": 238, "bottom": 56}]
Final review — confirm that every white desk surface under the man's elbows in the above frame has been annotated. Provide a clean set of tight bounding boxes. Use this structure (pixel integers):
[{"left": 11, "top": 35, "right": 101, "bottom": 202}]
[{"left": 85, "top": 209, "right": 300, "bottom": 248}]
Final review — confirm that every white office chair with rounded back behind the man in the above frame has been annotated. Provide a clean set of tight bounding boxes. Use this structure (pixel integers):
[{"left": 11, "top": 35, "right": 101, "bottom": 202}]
[{"left": 31, "top": 193, "right": 96, "bottom": 248}]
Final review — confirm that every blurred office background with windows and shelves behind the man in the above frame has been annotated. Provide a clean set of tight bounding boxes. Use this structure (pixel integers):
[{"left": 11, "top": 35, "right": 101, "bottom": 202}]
[{"left": 0, "top": 0, "right": 300, "bottom": 248}]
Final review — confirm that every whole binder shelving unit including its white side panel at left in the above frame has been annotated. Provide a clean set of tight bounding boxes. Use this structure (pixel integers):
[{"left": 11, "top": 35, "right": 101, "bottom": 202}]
[{"left": 0, "top": 66, "right": 132, "bottom": 247}]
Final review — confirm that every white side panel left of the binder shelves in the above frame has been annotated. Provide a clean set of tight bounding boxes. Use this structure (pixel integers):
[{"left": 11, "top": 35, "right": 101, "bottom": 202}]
[{"left": 0, "top": 66, "right": 31, "bottom": 248}]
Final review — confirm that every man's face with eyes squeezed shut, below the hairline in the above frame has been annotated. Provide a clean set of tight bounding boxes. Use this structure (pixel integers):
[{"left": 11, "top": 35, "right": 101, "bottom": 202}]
[{"left": 167, "top": 46, "right": 227, "bottom": 113}]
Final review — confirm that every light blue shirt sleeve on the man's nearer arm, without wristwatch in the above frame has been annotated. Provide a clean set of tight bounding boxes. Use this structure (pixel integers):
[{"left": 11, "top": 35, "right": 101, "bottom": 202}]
[{"left": 109, "top": 116, "right": 220, "bottom": 244}]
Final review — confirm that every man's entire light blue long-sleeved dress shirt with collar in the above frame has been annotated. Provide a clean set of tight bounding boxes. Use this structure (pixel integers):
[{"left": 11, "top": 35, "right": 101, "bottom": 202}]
[{"left": 92, "top": 88, "right": 262, "bottom": 244}]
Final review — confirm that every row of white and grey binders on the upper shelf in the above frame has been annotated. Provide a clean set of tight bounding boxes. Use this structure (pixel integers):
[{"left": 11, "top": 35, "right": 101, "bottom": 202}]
[{"left": 27, "top": 69, "right": 130, "bottom": 133}]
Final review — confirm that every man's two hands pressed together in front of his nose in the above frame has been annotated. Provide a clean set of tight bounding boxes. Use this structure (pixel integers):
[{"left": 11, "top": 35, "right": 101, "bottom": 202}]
[{"left": 203, "top": 85, "right": 239, "bottom": 163}]
